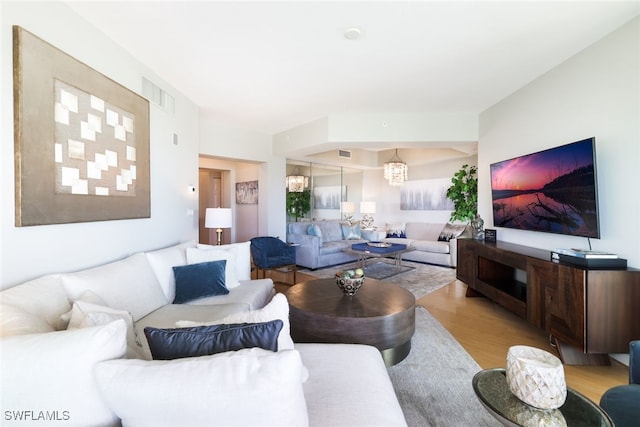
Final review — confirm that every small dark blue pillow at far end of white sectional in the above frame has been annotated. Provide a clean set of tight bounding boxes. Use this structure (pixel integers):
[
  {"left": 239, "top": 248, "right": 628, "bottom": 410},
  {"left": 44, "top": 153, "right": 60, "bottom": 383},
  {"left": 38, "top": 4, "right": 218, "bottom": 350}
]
[{"left": 173, "top": 260, "right": 229, "bottom": 304}]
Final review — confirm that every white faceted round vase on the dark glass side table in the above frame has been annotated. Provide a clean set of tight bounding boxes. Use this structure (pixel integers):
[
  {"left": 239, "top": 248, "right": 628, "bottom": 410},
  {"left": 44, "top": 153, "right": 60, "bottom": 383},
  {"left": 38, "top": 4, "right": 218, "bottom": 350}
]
[{"left": 506, "top": 345, "right": 567, "bottom": 409}]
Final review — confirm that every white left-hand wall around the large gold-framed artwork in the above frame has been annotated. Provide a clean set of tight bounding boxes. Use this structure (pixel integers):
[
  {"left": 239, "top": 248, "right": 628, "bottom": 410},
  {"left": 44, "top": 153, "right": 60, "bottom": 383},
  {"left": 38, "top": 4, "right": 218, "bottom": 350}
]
[{"left": 0, "top": 1, "right": 199, "bottom": 288}]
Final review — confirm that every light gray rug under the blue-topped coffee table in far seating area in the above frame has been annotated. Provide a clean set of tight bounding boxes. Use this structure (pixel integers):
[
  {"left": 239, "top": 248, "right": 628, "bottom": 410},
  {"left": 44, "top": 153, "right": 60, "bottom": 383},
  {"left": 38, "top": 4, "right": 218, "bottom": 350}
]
[{"left": 299, "top": 261, "right": 456, "bottom": 299}]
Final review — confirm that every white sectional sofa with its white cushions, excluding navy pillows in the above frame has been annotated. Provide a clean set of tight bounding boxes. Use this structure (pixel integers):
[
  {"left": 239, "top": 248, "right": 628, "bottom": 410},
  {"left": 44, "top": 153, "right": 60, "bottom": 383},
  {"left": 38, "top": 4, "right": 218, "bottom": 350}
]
[{"left": 0, "top": 242, "right": 406, "bottom": 427}]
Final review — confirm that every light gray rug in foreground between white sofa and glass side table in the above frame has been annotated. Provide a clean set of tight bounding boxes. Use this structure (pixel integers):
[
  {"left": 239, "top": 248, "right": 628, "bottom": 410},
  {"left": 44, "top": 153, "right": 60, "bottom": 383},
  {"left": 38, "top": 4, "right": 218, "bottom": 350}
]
[{"left": 388, "top": 306, "right": 501, "bottom": 427}]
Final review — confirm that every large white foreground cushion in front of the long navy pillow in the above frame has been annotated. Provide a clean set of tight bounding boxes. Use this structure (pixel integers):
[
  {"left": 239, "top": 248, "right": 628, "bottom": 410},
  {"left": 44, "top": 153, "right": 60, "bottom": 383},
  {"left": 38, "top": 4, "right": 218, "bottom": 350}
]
[{"left": 95, "top": 348, "right": 309, "bottom": 427}]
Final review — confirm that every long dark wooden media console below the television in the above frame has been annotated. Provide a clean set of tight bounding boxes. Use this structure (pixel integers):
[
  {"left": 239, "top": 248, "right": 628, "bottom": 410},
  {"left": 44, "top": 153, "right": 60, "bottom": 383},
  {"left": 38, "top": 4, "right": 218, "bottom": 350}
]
[{"left": 456, "top": 239, "right": 640, "bottom": 365}]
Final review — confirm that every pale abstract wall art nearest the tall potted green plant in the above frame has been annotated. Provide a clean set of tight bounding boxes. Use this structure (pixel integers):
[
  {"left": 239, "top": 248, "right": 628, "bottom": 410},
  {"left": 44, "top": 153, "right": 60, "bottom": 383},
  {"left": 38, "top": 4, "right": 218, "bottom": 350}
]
[{"left": 400, "top": 178, "right": 453, "bottom": 211}]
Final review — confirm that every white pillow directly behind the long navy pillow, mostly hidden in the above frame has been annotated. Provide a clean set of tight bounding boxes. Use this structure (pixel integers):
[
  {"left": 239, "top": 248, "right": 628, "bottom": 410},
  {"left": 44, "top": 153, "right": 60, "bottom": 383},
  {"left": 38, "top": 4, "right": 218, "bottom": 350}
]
[{"left": 176, "top": 294, "right": 293, "bottom": 351}]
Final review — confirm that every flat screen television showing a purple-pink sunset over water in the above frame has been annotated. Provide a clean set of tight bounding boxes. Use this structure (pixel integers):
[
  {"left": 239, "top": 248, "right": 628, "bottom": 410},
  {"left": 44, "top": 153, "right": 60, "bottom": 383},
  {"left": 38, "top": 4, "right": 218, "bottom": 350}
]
[{"left": 490, "top": 138, "right": 600, "bottom": 238}]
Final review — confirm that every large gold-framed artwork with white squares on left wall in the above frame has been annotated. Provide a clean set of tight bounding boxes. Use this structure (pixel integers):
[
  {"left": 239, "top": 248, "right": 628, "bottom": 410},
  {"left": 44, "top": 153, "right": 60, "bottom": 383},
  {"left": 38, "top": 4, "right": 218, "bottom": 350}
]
[{"left": 13, "top": 26, "right": 151, "bottom": 226}]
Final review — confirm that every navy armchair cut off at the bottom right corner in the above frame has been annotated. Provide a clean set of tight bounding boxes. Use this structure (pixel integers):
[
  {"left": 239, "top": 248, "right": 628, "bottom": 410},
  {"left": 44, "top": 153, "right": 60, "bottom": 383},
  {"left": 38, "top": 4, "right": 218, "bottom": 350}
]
[{"left": 600, "top": 340, "right": 640, "bottom": 427}]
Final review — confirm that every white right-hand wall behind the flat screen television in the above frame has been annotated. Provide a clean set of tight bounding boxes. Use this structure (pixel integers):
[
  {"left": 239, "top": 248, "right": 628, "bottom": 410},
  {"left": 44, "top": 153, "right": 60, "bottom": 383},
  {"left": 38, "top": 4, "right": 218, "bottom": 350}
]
[{"left": 478, "top": 18, "right": 640, "bottom": 268}]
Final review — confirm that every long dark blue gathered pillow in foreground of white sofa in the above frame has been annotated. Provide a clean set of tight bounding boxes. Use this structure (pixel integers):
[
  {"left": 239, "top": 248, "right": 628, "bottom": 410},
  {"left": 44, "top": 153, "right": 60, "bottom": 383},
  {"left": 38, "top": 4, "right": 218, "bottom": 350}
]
[{"left": 144, "top": 319, "right": 284, "bottom": 360}]
